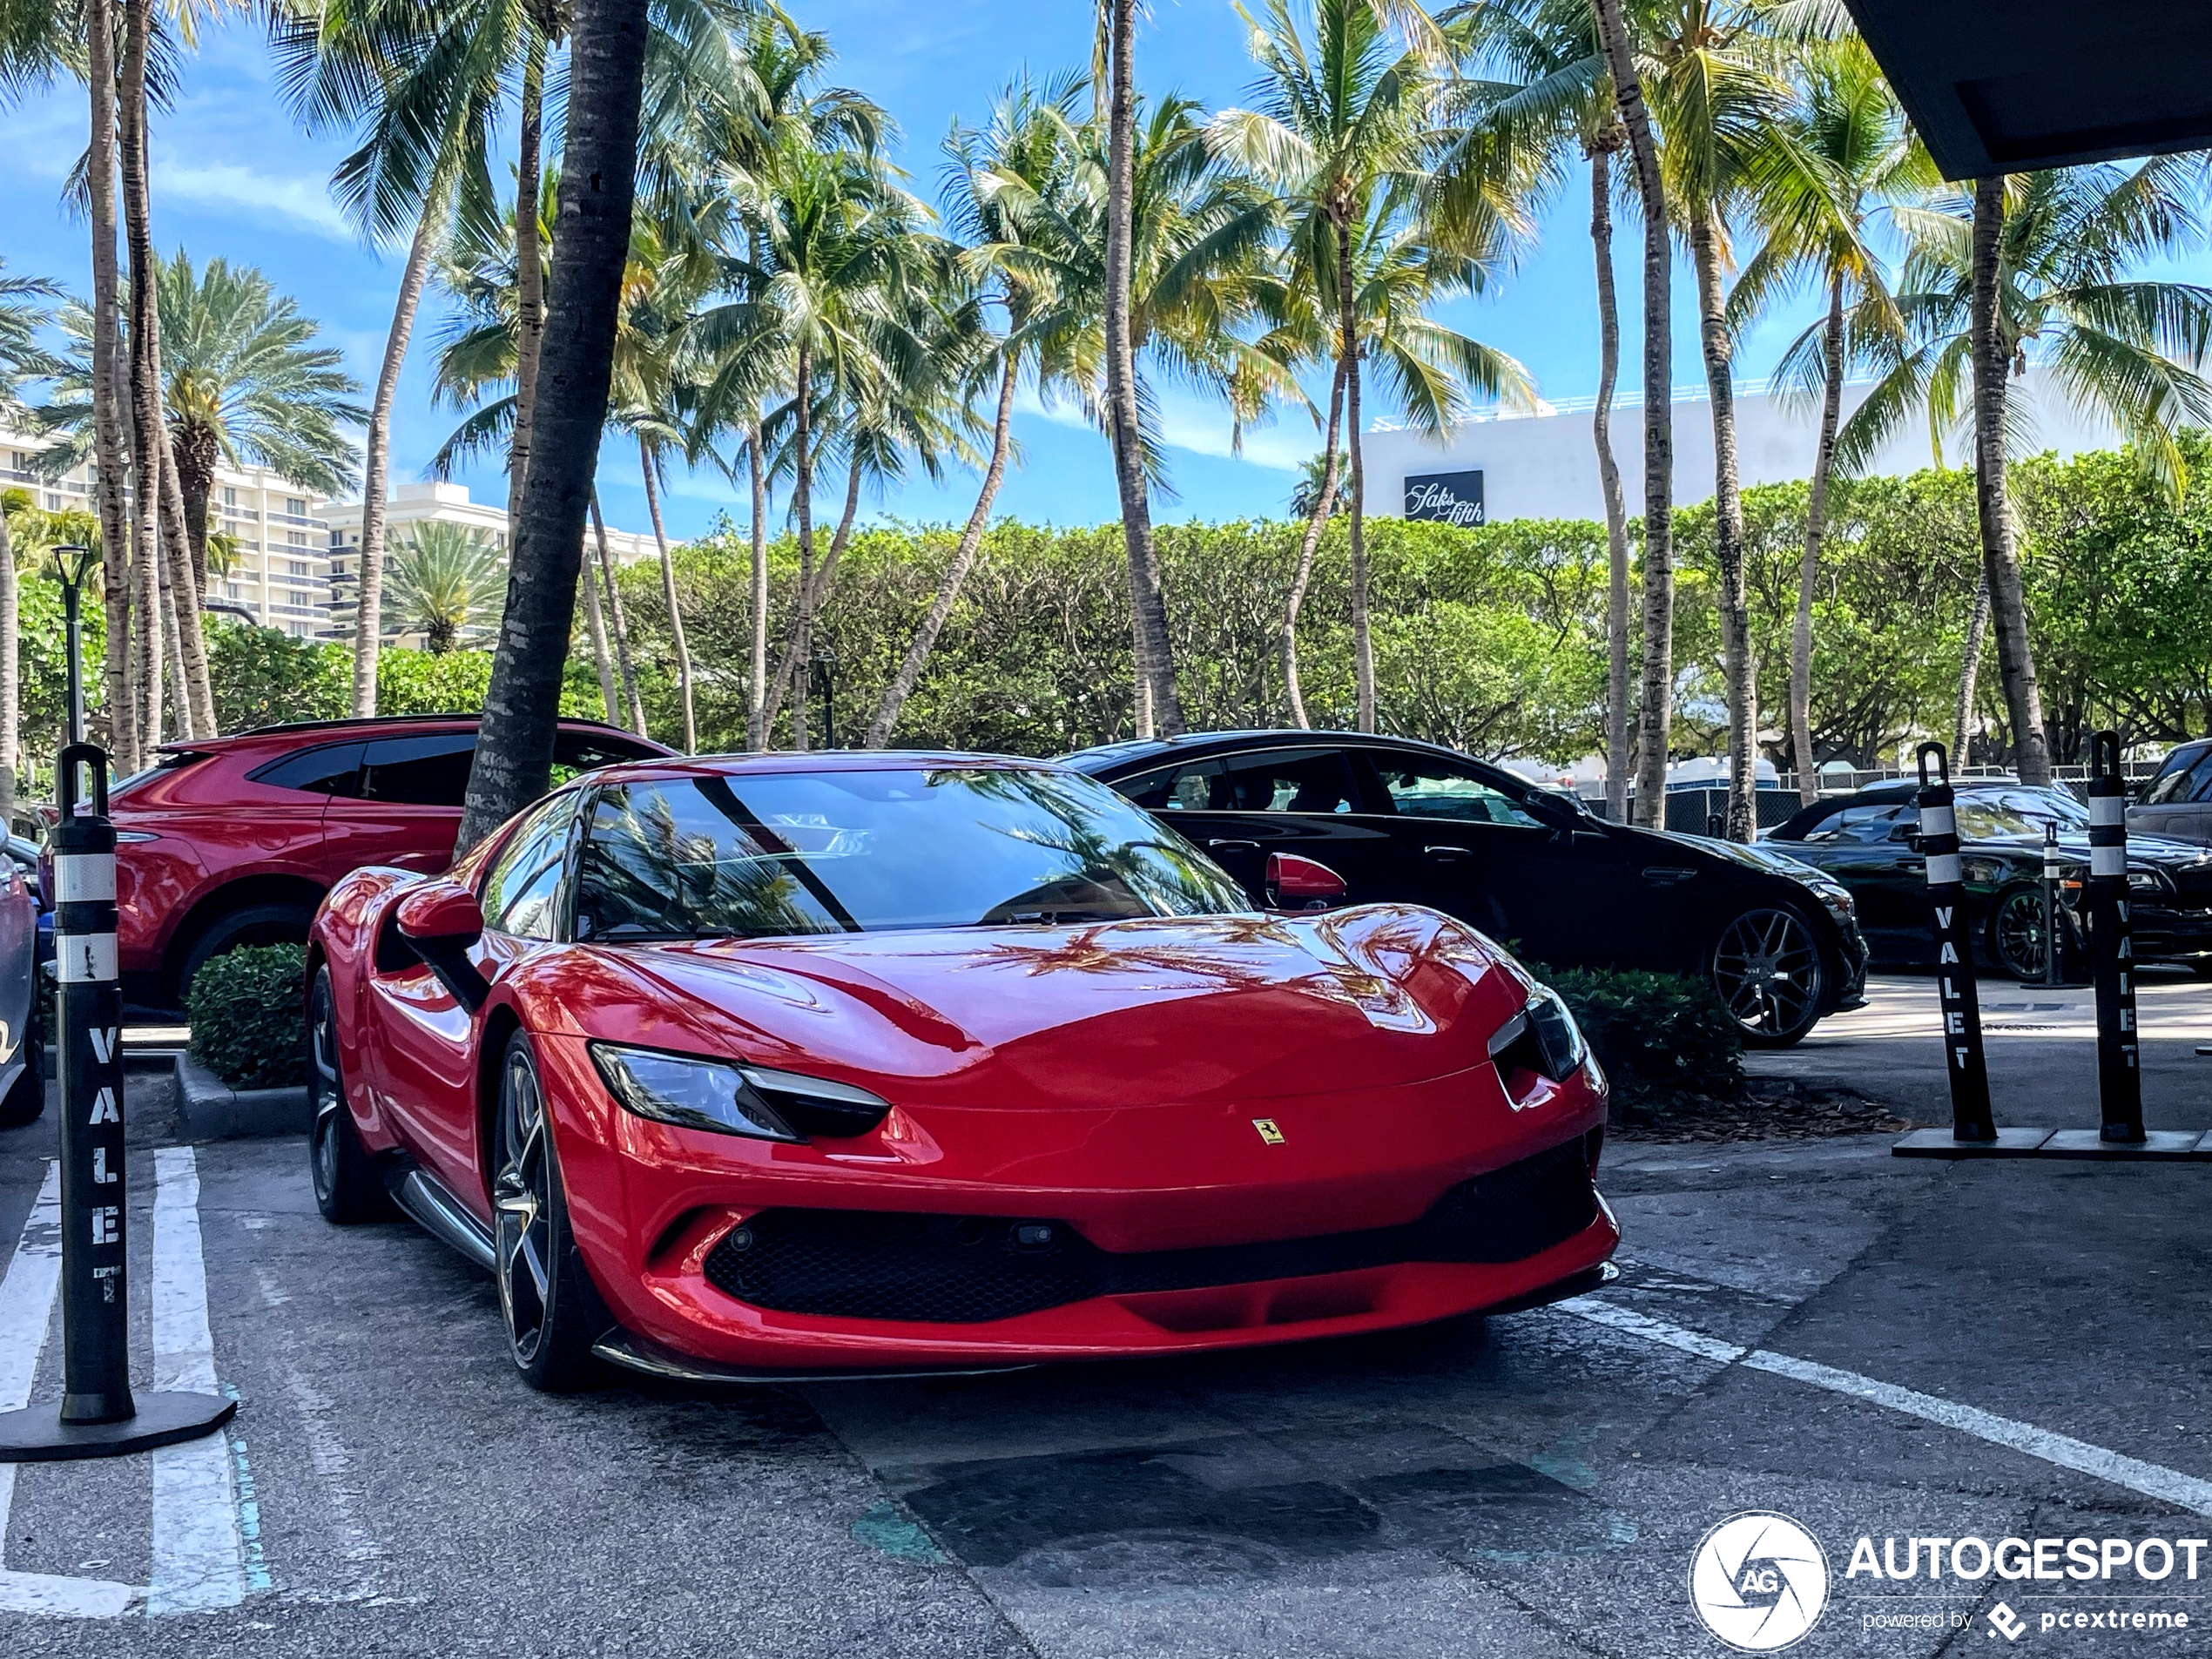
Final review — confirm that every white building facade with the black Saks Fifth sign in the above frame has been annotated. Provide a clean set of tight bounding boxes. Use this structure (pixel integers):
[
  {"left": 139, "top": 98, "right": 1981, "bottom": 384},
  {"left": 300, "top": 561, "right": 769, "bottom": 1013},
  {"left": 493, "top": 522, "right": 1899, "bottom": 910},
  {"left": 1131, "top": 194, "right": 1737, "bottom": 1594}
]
[{"left": 1365, "top": 369, "right": 2123, "bottom": 524}]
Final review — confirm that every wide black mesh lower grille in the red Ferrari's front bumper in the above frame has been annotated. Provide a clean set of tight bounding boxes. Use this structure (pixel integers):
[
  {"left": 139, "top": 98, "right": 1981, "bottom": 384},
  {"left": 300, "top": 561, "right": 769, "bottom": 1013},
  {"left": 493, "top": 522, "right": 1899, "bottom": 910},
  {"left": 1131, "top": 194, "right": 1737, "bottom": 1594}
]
[{"left": 705, "top": 1139, "right": 1597, "bottom": 1325}]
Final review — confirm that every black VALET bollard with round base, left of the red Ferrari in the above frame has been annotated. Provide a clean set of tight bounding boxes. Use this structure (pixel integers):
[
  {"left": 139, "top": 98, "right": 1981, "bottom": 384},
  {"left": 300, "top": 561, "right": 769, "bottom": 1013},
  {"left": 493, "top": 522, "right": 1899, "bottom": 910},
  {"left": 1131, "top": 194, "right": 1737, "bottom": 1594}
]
[{"left": 0, "top": 743, "right": 237, "bottom": 1462}]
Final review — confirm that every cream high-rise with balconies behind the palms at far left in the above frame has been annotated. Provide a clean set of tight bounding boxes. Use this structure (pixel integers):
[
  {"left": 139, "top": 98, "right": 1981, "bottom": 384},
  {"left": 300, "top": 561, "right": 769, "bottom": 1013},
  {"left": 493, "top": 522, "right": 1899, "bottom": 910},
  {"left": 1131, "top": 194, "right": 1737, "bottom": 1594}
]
[{"left": 0, "top": 429, "right": 329, "bottom": 639}]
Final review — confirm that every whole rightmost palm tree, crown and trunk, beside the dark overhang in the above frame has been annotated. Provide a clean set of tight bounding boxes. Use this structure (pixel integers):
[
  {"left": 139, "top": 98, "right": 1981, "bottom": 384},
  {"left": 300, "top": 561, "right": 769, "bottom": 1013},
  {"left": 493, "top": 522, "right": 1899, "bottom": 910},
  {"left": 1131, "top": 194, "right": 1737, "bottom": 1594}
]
[{"left": 1836, "top": 155, "right": 2212, "bottom": 783}]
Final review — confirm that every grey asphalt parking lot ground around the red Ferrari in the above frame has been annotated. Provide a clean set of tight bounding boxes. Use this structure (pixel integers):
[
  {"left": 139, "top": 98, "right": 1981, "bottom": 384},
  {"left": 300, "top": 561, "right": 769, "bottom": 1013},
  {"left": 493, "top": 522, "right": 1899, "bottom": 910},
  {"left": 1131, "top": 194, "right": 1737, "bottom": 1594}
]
[{"left": 0, "top": 980, "right": 2212, "bottom": 1659}]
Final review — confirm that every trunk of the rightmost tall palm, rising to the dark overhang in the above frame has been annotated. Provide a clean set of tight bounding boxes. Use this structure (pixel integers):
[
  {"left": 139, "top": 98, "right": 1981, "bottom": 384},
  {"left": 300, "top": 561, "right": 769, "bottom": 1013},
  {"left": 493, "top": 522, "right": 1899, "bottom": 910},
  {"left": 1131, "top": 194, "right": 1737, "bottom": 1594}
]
[{"left": 1973, "top": 177, "right": 2051, "bottom": 786}]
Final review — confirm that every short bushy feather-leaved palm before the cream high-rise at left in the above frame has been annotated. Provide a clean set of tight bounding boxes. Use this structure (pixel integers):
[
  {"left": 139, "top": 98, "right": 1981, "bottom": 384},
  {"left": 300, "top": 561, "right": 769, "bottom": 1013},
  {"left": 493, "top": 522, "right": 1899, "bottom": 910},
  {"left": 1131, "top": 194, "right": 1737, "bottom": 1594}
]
[{"left": 155, "top": 247, "right": 368, "bottom": 589}]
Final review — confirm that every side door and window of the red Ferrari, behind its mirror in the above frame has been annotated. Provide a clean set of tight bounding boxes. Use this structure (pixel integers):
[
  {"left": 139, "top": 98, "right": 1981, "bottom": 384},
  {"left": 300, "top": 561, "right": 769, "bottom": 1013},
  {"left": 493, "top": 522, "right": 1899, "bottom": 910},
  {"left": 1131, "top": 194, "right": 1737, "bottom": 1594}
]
[{"left": 368, "top": 790, "right": 577, "bottom": 1221}]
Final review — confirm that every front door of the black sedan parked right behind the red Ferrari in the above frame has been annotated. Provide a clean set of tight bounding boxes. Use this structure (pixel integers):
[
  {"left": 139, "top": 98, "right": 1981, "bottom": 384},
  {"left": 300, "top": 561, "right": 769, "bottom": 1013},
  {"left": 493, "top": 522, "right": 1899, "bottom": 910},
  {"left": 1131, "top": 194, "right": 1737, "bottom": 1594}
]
[{"left": 1367, "top": 748, "right": 1663, "bottom": 967}]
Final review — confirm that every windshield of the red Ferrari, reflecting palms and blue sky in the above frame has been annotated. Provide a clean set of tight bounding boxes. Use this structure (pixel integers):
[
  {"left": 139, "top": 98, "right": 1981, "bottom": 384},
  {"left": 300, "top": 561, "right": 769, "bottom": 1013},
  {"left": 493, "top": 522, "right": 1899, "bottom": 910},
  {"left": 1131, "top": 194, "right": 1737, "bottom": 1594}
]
[{"left": 575, "top": 767, "right": 1252, "bottom": 941}]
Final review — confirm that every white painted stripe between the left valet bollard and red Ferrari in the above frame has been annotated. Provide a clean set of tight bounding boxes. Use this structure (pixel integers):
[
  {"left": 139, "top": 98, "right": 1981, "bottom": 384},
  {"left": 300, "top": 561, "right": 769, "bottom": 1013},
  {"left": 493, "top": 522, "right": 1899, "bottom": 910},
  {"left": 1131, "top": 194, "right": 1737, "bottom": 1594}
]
[{"left": 146, "top": 1146, "right": 246, "bottom": 1615}]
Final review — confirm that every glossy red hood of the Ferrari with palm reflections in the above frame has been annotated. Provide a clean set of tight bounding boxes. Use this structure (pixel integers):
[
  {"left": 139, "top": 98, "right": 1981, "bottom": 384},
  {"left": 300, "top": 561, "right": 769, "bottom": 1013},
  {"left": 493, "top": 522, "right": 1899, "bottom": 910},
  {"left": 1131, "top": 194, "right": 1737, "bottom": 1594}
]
[{"left": 586, "top": 905, "right": 1527, "bottom": 1109}]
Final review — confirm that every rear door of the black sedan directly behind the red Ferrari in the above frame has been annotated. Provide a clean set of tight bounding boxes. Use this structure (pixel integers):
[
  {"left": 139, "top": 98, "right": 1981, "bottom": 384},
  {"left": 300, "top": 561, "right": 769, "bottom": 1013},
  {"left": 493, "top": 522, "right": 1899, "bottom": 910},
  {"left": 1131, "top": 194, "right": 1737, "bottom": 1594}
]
[{"left": 1115, "top": 743, "right": 1398, "bottom": 905}]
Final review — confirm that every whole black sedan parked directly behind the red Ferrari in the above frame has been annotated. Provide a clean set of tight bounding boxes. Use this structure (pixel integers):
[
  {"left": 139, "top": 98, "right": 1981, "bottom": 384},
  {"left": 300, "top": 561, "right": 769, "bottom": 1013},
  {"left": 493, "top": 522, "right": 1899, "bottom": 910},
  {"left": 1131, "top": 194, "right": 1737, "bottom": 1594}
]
[{"left": 1064, "top": 732, "right": 1865, "bottom": 1046}]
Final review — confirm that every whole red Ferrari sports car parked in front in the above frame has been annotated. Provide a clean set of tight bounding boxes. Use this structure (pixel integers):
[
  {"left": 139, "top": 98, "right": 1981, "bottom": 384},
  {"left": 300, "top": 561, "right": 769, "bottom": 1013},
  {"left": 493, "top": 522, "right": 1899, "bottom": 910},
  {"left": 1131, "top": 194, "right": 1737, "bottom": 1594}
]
[{"left": 307, "top": 754, "right": 1619, "bottom": 1389}]
